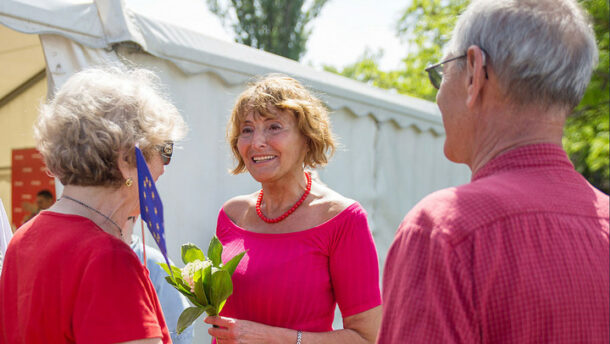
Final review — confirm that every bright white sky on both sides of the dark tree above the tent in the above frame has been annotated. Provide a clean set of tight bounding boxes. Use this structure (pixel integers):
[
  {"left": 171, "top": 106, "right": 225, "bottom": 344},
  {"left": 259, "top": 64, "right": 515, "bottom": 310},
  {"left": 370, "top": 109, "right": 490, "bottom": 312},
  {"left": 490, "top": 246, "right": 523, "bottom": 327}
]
[{"left": 126, "top": 0, "right": 409, "bottom": 69}]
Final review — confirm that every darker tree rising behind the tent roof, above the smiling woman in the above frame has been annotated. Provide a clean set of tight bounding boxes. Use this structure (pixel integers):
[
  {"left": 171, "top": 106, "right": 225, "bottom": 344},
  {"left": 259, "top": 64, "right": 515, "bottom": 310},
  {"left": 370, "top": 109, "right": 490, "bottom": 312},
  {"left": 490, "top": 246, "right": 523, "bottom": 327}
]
[{"left": 207, "top": 0, "right": 328, "bottom": 61}]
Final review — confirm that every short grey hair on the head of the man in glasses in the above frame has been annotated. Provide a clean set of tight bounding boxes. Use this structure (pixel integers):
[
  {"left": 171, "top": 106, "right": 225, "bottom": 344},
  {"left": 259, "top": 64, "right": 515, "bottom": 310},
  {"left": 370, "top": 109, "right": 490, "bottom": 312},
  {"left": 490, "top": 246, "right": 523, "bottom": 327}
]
[{"left": 447, "top": 0, "right": 598, "bottom": 108}]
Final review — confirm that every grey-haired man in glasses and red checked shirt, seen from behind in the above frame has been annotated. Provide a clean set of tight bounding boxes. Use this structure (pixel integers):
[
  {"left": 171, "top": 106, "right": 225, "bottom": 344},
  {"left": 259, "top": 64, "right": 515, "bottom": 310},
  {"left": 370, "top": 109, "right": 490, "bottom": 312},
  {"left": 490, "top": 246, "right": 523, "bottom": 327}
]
[{"left": 378, "top": 0, "right": 610, "bottom": 343}]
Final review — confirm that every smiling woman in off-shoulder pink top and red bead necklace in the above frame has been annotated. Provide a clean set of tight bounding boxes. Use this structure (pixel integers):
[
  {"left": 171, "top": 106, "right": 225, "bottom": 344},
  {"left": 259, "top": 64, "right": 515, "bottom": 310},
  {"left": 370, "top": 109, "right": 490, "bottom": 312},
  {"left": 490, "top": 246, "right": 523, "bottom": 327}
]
[{"left": 205, "top": 75, "right": 381, "bottom": 344}]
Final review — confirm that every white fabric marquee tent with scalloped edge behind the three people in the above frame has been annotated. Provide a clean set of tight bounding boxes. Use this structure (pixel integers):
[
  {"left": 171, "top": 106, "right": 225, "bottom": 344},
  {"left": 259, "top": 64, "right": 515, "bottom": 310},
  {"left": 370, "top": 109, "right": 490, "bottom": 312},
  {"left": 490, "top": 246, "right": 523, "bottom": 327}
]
[{"left": 0, "top": 0, "right": 470, "bottom": 338}]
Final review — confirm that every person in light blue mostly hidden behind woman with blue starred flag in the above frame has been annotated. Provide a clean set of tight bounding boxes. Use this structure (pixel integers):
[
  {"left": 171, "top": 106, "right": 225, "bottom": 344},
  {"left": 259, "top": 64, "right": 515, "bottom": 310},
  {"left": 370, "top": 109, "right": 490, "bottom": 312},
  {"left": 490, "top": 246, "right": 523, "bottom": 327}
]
[{"left": 123, "top": 216, "right": 194, "bottom": 344}]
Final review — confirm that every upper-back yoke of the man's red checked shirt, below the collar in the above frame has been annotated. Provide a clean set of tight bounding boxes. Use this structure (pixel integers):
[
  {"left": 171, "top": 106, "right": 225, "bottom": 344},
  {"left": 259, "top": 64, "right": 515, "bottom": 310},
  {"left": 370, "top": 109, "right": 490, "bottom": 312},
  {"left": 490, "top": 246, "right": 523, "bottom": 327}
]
[{"left": 401, "top": 171, "right": 609, "bottom": 241}]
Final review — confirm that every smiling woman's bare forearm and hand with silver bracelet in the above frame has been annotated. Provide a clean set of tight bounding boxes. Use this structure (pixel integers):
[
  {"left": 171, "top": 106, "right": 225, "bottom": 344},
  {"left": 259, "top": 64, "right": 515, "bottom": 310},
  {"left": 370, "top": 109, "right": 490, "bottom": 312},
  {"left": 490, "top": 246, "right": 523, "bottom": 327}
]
[{"left": 204, "top": 306, "right": 381, "bottom": 344}]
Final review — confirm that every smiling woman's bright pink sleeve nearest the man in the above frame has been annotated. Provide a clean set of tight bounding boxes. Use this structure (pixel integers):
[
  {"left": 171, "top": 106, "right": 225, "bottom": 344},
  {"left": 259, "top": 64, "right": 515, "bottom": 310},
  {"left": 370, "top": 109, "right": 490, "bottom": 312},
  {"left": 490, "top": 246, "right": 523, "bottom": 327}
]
[{"left": 330, "top": 206, "right": 381, "bottom": 318}]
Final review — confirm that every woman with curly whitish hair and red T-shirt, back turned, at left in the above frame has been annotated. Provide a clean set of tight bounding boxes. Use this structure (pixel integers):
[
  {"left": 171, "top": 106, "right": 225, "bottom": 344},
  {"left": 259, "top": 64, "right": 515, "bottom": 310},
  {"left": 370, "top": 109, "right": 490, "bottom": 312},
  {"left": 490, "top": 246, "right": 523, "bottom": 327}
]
[{"left": 0, "top": 68, "right": 186, "bottom": 343}]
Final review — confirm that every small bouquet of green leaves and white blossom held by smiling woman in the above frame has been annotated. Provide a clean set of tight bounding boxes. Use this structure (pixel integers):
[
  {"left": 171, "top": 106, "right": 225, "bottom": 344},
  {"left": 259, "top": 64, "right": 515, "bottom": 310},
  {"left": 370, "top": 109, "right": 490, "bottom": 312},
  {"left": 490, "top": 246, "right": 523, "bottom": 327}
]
[{"left": 159, "top": 236, "right": 246, "bottom": 334}]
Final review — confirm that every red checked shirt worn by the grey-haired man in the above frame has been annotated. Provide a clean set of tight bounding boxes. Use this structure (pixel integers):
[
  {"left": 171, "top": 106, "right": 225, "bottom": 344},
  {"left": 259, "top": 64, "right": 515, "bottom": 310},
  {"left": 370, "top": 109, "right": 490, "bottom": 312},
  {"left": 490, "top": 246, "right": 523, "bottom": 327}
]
[{"left": 378, "top": 144, "right": 610, "bottom": 344}]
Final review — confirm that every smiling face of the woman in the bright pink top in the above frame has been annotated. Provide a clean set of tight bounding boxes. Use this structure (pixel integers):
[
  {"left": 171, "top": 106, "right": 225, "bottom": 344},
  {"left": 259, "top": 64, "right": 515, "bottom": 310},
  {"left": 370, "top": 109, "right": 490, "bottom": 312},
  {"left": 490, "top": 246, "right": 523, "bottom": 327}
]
[{"left": 237, "top": 107, "right": 308, "bottom": 182}]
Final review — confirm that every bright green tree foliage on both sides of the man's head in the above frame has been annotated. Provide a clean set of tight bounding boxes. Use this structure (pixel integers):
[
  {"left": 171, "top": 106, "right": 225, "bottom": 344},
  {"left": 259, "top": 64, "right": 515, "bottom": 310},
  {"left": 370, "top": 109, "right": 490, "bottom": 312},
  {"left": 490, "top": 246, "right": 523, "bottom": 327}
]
[{"left": 324, "top": 0, "right": 610, "bottom": 193}]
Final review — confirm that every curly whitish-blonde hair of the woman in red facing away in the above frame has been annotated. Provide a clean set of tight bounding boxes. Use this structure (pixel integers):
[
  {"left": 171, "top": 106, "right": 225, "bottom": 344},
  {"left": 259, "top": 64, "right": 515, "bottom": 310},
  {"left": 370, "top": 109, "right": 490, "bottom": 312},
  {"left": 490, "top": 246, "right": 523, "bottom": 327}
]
[{"left": 34, "top": 67, "right": 186, "bottom": 187}]
